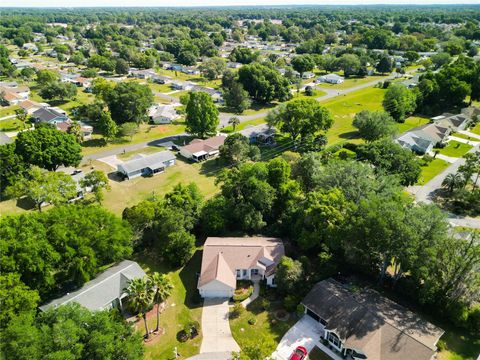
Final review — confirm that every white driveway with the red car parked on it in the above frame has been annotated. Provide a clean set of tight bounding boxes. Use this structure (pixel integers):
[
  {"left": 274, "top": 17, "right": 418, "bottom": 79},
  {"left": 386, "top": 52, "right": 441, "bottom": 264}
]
[{"left": 272, "top": 315, "right": 320, "bottom": 360}]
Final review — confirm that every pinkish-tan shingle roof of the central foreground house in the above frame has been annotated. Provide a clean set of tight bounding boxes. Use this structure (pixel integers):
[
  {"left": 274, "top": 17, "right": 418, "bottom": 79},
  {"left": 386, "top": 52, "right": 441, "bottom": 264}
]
[{"left": 198, "top": 237, "right": 285, "bottom": 288}]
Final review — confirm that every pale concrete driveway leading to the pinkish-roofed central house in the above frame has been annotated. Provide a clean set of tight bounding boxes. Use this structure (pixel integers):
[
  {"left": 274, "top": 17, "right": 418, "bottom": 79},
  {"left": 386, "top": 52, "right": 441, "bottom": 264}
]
[{"left": 200, "top": 299, "right": 240, "bottom": 359}]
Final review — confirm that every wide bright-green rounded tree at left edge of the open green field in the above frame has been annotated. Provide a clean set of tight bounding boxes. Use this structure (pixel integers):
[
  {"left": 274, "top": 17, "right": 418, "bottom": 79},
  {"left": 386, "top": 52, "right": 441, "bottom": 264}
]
[{"left": 267, "top": 99, "right": 333, "bottom": 140}]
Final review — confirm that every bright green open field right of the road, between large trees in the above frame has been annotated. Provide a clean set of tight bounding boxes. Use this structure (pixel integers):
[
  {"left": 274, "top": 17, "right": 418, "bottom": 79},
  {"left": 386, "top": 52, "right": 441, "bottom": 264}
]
[{"left": 320, "top": 87, "right": 385, "bottom": 145}]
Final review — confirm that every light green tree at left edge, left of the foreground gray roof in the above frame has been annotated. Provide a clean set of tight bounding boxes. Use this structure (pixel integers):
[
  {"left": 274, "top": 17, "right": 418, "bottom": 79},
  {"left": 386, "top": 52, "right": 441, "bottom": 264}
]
[{"left": 0, "top": 273, "right": 40, "bottom": 329}]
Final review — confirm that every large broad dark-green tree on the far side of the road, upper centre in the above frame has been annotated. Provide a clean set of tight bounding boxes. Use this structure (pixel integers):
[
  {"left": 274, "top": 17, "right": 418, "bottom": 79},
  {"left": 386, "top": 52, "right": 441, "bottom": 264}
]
[{"left": 238, "top": 63, "right": 291, "bottom": 103}]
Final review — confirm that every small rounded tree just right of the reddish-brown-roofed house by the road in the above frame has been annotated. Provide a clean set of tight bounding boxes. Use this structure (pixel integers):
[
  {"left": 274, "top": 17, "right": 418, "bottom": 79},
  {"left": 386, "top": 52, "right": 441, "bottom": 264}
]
[{"left": 220, "top": 134, "right": 260, "bottom": 165}]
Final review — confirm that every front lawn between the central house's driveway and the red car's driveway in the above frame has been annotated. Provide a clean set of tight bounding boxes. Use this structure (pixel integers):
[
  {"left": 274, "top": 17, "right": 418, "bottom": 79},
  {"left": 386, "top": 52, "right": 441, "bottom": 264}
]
[{"left": 230, "top": 297, "right": 296, "bottom": 352}]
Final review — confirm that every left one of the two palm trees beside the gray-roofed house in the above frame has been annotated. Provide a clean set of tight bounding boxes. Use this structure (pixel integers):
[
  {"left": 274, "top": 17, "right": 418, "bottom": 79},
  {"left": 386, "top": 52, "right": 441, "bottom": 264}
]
[{"left": 124, "top": 277, "right": 154, "bottom": 339}]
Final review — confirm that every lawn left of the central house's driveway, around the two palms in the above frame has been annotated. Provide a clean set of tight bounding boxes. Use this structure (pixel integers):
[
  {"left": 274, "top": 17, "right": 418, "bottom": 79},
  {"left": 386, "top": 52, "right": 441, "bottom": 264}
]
[{"left": 135, "top": 251, "right": 202, "bottom": 359}]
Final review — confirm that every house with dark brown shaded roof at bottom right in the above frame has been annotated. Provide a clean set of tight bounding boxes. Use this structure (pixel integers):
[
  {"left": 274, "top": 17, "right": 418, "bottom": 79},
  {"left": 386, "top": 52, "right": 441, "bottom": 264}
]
[{"left": 302, "top": 279, "right": 444, "bottom": 360}]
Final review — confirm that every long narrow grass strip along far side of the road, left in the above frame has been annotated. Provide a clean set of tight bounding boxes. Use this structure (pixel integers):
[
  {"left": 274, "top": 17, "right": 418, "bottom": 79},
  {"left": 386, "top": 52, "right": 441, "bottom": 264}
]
[{"left": 82, "top": 122, "right": 185, "bottom": 155}]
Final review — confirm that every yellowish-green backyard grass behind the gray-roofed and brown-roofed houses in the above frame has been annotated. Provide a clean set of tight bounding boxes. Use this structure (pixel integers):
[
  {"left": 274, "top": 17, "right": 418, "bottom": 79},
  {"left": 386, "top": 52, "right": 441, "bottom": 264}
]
[{"left": 93, "top": 158, "right": 218, "bottom": 215}]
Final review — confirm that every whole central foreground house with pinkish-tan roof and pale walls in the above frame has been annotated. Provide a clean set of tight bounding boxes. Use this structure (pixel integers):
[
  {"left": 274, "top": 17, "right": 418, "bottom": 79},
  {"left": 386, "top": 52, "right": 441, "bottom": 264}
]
[{"left": 198, "top": 237, "right": 285, "bottom": 298}]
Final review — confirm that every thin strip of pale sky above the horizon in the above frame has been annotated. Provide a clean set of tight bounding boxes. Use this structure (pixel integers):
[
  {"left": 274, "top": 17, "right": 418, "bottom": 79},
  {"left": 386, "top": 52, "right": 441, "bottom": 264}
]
[{"left": 0, "top": 0, "right": 480, "bottom": 8}]
